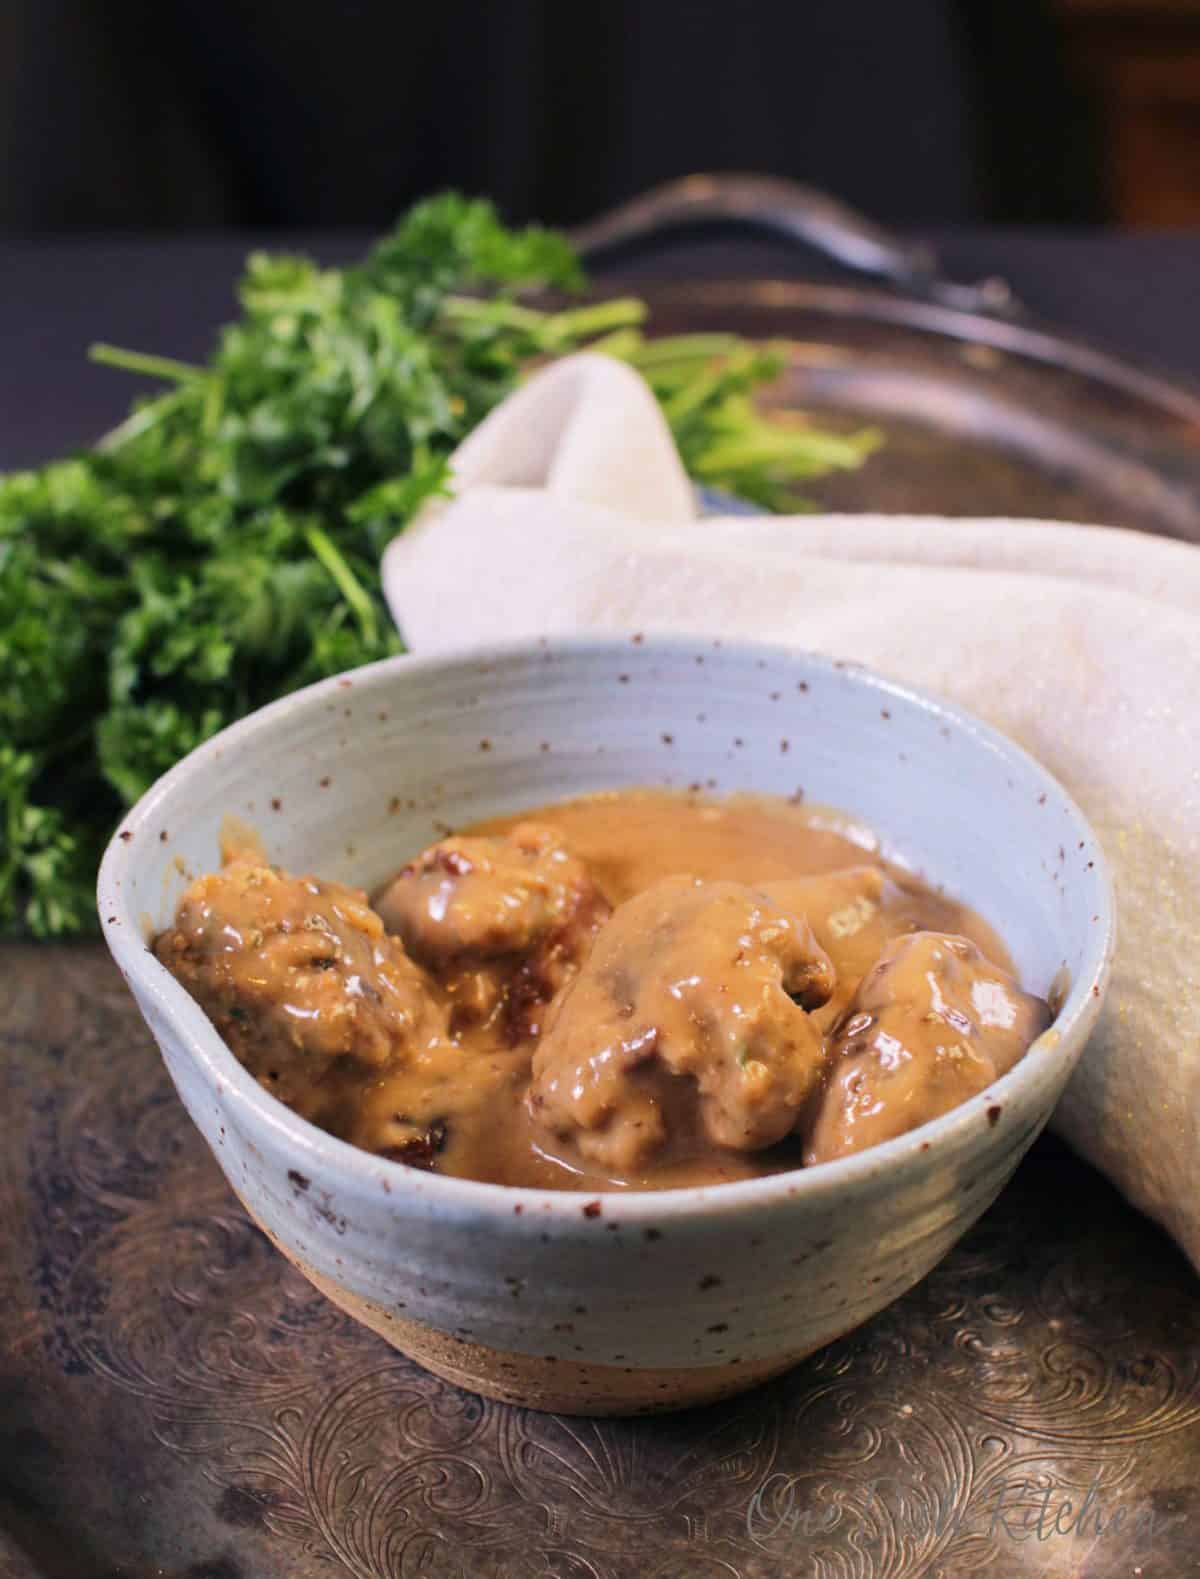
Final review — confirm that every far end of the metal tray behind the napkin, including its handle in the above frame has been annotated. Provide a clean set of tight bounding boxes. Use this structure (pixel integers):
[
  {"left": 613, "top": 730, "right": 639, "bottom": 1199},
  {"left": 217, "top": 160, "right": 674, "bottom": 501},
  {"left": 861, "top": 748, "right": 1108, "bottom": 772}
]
[{"left": 576, "top": 175, "right": 1200, "bottom": 542}]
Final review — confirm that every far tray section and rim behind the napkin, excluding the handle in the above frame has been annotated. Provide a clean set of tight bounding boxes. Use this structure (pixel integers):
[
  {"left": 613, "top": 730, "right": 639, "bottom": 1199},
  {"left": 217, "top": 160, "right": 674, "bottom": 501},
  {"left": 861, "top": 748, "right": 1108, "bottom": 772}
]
[{"left": 624, "top": 281, "right": 1200, "bottom": 543}]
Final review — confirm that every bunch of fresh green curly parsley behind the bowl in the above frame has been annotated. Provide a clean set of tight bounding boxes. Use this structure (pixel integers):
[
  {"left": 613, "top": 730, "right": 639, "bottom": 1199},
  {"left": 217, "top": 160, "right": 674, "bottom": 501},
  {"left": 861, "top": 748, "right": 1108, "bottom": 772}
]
[{"left": 0, "top": 194, "right": 875, "bottom": 936}]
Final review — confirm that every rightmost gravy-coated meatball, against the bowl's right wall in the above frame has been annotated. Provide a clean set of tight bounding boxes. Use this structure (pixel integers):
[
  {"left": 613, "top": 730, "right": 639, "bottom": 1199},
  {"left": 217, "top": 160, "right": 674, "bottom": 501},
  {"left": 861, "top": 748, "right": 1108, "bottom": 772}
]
[{"left": 804, "top": 932, "right": 1050, "bottom": 1164}]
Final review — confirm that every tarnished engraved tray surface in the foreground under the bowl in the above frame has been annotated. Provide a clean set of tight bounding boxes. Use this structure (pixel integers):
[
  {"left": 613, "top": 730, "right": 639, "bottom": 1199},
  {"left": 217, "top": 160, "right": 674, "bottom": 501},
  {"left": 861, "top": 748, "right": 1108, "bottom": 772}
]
[{"left": 0, "top": 946, "right": 1200, "bottom": 1579}]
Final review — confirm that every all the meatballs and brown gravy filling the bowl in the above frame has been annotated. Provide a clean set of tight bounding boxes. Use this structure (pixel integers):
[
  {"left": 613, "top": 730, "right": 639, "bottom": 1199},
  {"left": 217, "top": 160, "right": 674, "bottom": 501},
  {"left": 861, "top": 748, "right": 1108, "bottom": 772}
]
[{"left": 155, "top": 790, "right": 1048, "bottom": 1191}]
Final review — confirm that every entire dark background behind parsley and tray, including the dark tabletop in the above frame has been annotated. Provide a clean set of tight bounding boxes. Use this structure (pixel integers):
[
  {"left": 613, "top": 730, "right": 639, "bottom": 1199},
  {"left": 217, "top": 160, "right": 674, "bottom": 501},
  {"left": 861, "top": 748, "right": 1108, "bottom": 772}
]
[{"left": 0, "top": 0, "right": 1200, "bottom": 471}]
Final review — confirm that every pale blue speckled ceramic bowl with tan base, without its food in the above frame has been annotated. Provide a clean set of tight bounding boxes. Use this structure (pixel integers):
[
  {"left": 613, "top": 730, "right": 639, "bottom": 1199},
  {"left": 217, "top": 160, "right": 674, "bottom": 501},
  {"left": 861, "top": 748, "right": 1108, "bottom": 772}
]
[{"left": 99, "top": 638, "right": 1113, "bottom": 1415}]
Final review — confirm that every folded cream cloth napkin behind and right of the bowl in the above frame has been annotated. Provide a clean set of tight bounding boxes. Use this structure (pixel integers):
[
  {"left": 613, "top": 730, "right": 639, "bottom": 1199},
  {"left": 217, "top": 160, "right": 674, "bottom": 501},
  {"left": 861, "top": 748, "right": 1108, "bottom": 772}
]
[{"left": 384, "top": 355, "right": 1200, "bottom": 1270}]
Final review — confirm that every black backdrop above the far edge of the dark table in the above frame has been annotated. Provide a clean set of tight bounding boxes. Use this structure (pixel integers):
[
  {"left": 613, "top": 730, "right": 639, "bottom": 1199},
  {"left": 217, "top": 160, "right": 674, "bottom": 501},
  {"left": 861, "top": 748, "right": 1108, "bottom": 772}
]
[{"left": 0, "top": 0, "right": 1110, "bottom": 234}]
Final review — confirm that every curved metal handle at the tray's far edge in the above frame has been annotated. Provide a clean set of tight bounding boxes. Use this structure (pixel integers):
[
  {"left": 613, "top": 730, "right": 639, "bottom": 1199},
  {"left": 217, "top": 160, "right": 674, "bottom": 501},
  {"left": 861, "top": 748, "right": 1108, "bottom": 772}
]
[{"left": 572, "top": 174, "right": 1018, "bottom": 317}]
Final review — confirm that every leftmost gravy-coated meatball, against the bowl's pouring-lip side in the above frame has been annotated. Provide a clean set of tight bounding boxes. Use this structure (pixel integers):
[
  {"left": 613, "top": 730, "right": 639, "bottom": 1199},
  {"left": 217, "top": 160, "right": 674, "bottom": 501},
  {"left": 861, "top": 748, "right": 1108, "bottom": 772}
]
[{"left": 155, "top": 857, "right": 445, "bottom": 1127}]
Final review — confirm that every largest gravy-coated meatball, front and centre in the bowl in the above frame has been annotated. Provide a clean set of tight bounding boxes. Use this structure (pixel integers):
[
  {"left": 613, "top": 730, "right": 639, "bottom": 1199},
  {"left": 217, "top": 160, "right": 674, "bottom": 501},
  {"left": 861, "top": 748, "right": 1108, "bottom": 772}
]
[{"left": 529, "top": 878, "right": 834, "bottom": 1172}]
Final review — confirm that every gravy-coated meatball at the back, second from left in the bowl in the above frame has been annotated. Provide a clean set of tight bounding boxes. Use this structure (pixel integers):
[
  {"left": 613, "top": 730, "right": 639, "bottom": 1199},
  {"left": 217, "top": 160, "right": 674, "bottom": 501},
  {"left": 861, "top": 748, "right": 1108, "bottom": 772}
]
[{"left": 379, "top": 823, "right": 609, "bottom": 1039}]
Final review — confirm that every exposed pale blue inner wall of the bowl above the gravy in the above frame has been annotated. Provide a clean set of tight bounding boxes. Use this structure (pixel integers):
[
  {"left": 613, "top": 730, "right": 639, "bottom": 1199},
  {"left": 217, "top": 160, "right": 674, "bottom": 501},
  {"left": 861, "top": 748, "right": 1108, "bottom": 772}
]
[{"left": 110, "top": 638, "right": 1108, "bottom": 995}]
